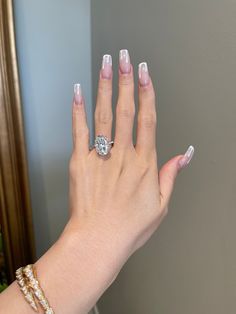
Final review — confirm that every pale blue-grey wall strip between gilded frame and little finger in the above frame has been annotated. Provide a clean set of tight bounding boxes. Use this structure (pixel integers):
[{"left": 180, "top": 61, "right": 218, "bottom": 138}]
[{"left": 14, "top": 0, "right": 92, "bottom": 256}]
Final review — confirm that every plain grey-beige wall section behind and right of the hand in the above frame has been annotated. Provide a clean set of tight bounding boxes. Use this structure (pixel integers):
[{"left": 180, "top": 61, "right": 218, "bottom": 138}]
[{"left": 92, "top": 0, "right": 236, "bottom": 314}]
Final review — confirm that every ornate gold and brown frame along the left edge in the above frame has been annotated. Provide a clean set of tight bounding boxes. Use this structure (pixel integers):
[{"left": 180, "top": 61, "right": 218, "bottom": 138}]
[{"left": 0, "top": 0, "right": 35, "bottom": 283}]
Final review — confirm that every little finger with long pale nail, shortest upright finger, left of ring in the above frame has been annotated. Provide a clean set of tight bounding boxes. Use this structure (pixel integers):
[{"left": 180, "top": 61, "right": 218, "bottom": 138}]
[{"left": 72, "top": 84, "right": 89, "bottom": 155}]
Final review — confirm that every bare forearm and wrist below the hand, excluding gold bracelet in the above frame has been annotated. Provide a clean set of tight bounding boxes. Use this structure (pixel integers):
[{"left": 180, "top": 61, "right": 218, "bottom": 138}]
[{"left": 0, "top": 218, "right": 130, "bottom": 314}]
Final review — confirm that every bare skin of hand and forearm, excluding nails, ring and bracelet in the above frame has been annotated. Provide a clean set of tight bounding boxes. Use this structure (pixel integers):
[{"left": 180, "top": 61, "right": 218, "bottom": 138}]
[{"left": 0, "top": 54, "right": 192, "bottom": 314}]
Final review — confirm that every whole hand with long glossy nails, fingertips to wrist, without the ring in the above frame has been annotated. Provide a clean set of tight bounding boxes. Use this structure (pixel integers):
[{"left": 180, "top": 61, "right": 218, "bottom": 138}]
[{"left": 70, "top": 50, "right": 193, "bottom": 257}]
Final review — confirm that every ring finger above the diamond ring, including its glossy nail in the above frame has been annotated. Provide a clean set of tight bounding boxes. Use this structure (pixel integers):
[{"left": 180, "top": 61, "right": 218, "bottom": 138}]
[{"left": 95, "top": 55, "right": 112, "bottom": 139}]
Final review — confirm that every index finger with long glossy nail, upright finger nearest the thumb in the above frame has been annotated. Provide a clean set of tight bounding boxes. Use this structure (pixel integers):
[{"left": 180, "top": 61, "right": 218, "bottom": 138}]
[{"left": 135, "top": 62, "right": 157, "bottom": 158}]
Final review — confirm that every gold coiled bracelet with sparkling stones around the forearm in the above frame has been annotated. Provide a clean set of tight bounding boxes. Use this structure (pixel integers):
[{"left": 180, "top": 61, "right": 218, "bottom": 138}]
[{"left": 16, "top": 264, "right": 54, "bottom": 314}]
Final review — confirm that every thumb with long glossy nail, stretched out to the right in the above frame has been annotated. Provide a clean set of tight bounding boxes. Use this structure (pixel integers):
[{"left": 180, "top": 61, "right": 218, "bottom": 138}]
[{"left": 159, "top": 146, "right": 194, "bottom": 208}]
